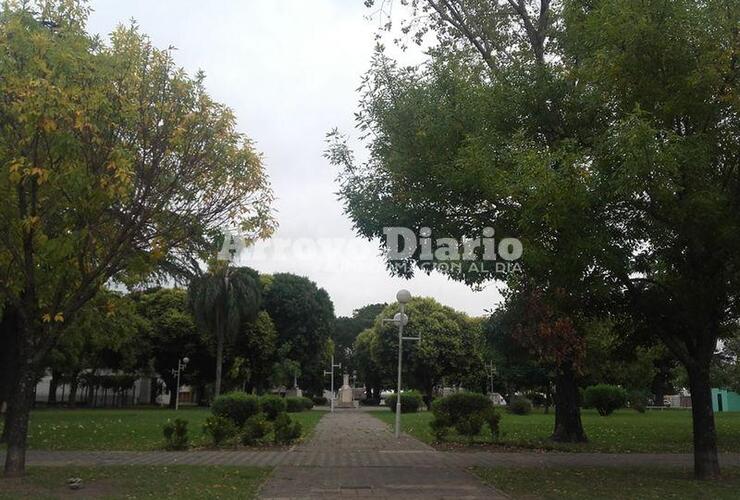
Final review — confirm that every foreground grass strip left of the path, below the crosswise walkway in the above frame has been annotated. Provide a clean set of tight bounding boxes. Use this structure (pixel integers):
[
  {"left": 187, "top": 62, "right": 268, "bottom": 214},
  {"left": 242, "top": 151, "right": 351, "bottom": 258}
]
[{"left": 0, "top": 465, "right": 271, "bottom": 499}]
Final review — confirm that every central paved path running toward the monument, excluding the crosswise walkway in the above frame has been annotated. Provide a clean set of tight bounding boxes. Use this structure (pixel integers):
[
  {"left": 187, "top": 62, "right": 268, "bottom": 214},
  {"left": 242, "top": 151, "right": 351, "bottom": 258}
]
[{"left": 261, "top": 410, "right": 505, "bottom": 500}]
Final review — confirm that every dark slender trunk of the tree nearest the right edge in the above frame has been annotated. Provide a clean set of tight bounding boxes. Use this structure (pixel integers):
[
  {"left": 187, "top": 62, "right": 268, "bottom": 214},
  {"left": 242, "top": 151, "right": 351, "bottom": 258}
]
[{"left": 687, "top": 362, "right": 719, "bottom": 479}]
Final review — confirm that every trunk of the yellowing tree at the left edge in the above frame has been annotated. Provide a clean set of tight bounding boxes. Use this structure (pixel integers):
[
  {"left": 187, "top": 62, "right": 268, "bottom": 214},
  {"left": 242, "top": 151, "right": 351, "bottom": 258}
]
[{"left": 5, "top": 365, "right": 36, "bottom": 477}]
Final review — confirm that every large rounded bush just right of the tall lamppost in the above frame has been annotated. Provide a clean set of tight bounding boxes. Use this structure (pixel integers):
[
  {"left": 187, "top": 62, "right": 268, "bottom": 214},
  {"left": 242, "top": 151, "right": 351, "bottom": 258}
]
[{"left": 430, "top": 392, "right": 499, "bottom": 442}]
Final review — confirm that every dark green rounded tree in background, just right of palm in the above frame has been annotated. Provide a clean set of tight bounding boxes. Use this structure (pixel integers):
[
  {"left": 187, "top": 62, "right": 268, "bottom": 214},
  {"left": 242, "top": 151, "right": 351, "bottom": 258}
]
[{"left": 264, "top": 273, "right": 335, "bottom": 393}]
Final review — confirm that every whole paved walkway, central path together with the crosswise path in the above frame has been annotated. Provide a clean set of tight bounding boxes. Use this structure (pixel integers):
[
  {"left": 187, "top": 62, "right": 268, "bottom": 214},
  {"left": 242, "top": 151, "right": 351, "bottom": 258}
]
[{"left": 0, "top": 410, "right": 740, "bottom": 498}]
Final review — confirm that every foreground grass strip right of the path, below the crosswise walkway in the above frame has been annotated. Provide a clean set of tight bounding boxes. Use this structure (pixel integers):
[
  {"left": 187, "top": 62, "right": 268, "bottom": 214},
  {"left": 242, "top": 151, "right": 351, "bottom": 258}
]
[{"left": 473, "top": 467, "right": 740, "bottom": 500}]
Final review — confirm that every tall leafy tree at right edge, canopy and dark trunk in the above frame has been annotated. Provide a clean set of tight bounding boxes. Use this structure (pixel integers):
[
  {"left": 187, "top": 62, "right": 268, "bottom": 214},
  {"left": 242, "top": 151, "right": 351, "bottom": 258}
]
[{"left": 564, "top": 0, "right": 740, "bottom": 479}]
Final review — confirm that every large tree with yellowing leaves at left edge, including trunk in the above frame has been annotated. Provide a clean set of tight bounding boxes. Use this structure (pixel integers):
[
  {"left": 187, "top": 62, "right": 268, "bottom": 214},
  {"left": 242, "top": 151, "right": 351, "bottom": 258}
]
[{"left": 0, "top": 0, "right": 273, "bottom": 476}]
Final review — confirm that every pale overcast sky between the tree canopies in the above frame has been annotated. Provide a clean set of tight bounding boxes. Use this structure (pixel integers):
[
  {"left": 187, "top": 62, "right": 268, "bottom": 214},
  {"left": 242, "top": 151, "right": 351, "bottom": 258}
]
[{"left": 88, "top": 0, "right": 501, "bottom": 315}]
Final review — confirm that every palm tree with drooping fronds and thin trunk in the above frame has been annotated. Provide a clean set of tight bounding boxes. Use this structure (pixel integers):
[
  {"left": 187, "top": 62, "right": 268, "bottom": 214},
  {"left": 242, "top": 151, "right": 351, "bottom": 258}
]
[{"left": 188, "top": 262, "right": 262, "bottom": 396}]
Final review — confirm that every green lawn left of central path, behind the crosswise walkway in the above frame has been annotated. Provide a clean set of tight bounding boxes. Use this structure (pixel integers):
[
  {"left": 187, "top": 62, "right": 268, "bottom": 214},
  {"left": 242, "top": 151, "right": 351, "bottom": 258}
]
[{"left": 0, "top": 408, "right": 326, "bottom": 451}]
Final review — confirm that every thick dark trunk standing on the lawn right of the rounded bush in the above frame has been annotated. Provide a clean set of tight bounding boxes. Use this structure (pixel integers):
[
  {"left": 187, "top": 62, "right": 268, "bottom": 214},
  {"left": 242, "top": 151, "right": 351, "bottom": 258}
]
[{"left": 550, "top": 365, "right": 588, "bottom": 443}]
